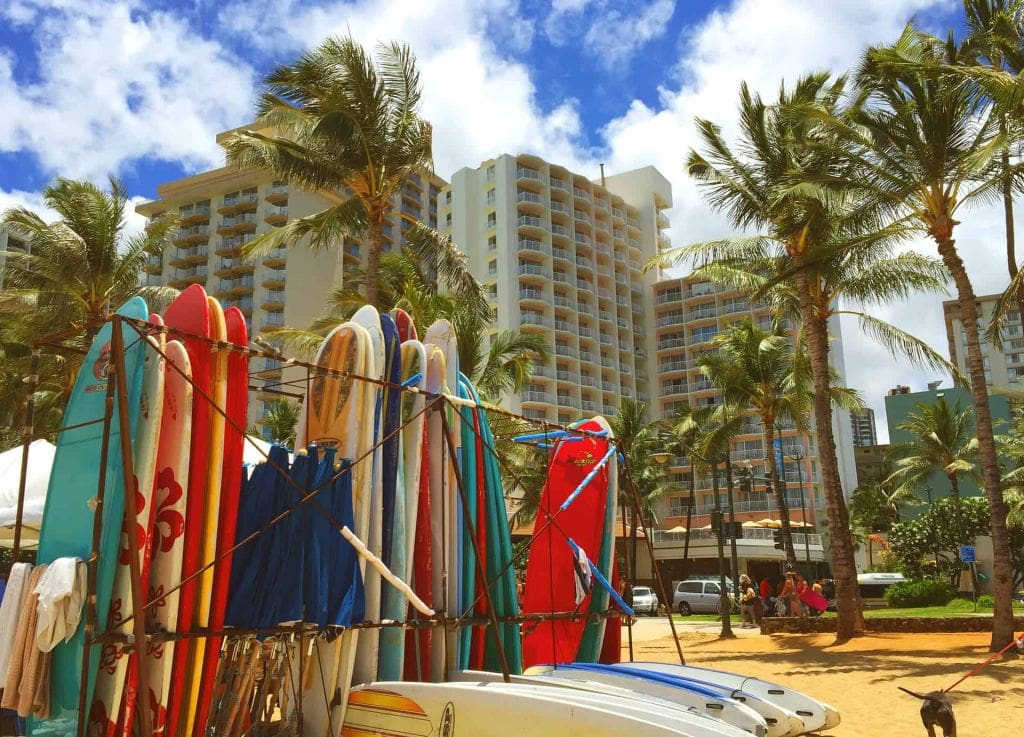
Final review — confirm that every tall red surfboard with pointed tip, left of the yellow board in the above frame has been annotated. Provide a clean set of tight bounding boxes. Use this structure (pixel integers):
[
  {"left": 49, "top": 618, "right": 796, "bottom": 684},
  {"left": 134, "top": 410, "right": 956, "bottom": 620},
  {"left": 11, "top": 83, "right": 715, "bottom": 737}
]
[{"left": 164, "top": 285, "right": 211, "bottom": 735}]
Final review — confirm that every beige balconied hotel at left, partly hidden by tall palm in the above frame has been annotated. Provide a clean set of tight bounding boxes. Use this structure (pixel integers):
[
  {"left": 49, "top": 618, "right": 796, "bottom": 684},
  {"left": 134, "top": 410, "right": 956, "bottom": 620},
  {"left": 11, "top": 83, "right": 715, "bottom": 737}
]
[{"left": 136, "top": 123, "right": 444, "bottom": 424}]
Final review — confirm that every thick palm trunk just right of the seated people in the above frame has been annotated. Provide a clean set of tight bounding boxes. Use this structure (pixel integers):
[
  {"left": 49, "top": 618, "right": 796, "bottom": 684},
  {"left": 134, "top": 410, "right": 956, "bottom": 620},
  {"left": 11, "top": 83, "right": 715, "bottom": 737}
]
[{"left": 795, "top": 271, "right": 864, "bottom": 640}]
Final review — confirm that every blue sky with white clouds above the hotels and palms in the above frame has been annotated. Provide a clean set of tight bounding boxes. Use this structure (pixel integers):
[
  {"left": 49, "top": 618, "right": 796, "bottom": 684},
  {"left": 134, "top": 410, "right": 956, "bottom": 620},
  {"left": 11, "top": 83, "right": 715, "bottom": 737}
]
[{"left": 0, "top": 0, "right": 1006, "bottom": 438}]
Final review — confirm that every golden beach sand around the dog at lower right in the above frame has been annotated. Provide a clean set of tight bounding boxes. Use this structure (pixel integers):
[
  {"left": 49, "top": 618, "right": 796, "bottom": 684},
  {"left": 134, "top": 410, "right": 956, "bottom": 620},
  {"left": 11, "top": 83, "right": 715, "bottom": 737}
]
[{"left": 624, "top": 633, "right": 1024, "bottom": 737}]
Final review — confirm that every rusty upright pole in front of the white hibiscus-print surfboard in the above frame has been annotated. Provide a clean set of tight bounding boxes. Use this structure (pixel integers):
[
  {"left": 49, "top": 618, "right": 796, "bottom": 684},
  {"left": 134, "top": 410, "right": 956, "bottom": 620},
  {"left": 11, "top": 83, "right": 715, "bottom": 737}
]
[{"left": 111, "top": 316, "right": 154, "bottom": 735}]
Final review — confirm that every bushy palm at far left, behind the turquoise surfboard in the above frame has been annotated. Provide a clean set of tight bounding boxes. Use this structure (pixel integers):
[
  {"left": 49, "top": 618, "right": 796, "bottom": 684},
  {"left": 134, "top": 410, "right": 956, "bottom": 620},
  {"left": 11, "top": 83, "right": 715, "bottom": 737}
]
[{"left": 0, "top": 177, "right": 175, "bottom": 433}]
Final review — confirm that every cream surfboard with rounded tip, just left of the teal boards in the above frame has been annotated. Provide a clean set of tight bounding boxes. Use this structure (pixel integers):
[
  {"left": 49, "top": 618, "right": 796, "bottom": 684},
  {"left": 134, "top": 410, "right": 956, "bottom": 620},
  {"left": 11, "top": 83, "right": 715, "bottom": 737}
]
[{"left": 423, "top": 319, "right": 463, "bottom": 680}]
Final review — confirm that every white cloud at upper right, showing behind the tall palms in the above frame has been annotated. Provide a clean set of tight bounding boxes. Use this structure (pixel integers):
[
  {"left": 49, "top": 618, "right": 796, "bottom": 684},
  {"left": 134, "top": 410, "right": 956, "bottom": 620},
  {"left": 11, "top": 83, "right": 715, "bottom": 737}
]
[{"left": 602, "top": 0, "right": 978, "bottom": 436}]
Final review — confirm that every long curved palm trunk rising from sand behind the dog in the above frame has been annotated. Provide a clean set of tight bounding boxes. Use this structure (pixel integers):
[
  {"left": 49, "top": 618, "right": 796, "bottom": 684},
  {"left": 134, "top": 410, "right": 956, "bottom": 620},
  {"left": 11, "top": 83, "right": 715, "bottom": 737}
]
[{"left": 933, "top": 234, "right": 1014, "bottom": 652}]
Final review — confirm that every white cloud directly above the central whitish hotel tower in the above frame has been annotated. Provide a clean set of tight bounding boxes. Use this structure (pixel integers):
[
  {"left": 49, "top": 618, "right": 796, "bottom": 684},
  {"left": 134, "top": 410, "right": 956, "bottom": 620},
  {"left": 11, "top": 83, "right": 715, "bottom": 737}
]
[{"left": 214, "top": 0, "right": 584, "bottom": 177}]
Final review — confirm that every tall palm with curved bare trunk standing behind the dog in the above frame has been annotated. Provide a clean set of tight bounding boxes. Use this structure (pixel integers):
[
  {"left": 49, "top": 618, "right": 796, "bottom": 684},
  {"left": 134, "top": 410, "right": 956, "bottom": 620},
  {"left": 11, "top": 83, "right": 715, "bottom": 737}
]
[{"left": 847, "top": 26, "right": 1020, "bottom": 651}]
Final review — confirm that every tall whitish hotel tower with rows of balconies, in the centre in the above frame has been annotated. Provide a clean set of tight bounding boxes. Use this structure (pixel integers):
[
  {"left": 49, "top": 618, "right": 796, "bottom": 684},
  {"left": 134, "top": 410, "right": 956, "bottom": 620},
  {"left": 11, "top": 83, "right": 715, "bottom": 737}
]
[{"left": 440, "top": 155, "right": 672, "bottom": 423}]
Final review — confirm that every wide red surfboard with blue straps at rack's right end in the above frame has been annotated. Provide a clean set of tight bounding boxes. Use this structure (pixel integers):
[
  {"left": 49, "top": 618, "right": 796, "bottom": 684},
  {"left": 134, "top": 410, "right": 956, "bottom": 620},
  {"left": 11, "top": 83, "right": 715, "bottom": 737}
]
[{"left": 522, "top": 420, "right": 608, "bottom": 667}]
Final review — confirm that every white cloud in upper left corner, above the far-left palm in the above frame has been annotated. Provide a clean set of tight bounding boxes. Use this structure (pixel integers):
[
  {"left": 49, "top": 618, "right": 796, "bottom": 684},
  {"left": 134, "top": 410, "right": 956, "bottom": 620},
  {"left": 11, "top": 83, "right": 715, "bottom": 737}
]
[{"left": 0, "top": 0, "right": 254, "bottom": 180}]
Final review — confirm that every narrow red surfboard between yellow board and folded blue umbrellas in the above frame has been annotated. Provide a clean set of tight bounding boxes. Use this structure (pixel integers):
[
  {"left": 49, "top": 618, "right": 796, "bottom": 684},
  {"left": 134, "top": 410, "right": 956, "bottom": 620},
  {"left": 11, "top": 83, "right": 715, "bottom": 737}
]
[{"left": 196, "top": 307, "right": 249, "bottom": 735}]
